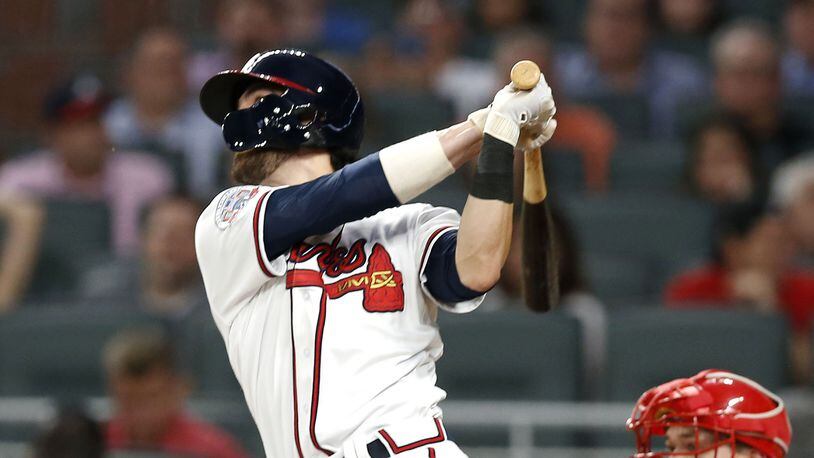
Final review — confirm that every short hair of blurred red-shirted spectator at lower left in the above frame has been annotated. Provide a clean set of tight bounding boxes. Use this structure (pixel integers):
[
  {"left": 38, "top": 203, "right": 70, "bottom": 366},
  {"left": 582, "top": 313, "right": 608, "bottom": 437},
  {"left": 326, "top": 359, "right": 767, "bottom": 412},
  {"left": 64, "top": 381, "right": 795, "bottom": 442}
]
[{"left": 104, "top": 328, "right": 177, "bottom": 378}]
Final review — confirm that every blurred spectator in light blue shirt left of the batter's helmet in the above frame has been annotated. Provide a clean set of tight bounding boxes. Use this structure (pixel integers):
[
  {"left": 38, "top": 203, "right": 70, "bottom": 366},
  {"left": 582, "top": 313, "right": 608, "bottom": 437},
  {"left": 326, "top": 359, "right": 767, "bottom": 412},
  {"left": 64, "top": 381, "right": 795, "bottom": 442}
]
[{"left": 104, "top": 29, "right": 225, "bottom": 198}]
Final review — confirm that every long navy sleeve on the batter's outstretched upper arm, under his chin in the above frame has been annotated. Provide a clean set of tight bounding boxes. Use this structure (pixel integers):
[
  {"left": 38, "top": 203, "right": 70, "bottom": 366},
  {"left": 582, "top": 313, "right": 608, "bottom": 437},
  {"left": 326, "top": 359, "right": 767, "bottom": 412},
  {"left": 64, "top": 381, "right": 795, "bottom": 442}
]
[{"left": 263, "top": 153, "right": 399, "bottom": 259}]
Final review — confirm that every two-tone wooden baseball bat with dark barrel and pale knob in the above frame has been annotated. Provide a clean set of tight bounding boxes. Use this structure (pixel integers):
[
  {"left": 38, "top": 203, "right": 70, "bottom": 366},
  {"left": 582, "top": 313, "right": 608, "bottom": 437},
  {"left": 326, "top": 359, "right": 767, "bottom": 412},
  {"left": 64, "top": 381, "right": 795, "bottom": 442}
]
[{"left": 511, "top": 60, "right": 560, "bottom": 313}]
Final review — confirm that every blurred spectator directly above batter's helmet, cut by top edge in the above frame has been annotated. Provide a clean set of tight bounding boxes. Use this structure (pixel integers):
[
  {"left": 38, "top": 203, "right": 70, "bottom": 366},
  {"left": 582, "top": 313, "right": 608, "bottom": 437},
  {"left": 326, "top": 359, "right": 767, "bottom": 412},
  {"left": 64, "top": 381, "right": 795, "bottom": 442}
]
[{"left": 189, "top": 0, "right": 285, "bottom": 91}]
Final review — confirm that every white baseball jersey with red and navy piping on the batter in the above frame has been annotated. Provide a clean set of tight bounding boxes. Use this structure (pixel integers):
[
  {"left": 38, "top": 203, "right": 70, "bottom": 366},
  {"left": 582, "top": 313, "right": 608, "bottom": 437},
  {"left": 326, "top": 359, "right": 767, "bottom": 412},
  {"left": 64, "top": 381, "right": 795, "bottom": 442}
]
[{"left": 195, "top": 186, "right": 483, "bottom": 457}]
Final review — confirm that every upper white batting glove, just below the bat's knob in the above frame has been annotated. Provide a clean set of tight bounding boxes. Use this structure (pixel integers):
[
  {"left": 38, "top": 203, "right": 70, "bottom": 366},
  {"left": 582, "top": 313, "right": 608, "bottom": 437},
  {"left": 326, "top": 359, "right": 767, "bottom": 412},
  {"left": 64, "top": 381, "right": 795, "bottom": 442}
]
[{"left": 483, "top": 76, "right": 556, "bottom": 146}]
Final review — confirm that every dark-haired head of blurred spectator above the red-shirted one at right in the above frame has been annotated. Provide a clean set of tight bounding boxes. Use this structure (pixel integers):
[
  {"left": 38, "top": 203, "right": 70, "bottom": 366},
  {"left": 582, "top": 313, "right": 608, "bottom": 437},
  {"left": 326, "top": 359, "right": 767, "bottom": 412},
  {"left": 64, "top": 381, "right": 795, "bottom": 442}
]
[{"left": 685, "top": 115, "right": 763, "bottom": 205}]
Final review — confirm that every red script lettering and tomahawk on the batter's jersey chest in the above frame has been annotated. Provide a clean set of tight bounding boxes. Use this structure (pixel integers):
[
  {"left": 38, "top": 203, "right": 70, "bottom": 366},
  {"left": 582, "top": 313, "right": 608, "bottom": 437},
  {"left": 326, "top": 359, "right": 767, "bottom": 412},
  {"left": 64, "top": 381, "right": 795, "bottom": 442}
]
[{"left": 286, "top": 236, "right": 404, "bottom": 312}]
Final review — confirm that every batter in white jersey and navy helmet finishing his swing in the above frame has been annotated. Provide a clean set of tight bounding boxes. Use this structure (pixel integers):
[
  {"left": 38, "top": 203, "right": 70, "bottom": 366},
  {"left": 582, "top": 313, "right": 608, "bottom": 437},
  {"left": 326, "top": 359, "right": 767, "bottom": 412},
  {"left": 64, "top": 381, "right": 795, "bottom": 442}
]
[{"left": 195, "top": 50, "right": 556, "bottom": 458}]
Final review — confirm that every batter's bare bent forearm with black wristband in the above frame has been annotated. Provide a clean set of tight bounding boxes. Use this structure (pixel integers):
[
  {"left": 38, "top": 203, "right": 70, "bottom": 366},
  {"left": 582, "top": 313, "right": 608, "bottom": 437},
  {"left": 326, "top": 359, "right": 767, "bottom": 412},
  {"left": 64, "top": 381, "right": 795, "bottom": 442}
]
[{"left": 455, "top": 135, "right": 514, "bottom": 291}]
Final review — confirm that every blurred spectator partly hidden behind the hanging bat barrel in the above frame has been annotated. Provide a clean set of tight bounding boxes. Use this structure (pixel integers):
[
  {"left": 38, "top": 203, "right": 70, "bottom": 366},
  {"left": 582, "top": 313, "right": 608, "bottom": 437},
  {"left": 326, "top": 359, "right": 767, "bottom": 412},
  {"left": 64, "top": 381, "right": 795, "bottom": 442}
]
[{"left": 480, "top": 211, "right": 607, "bottom": 394}]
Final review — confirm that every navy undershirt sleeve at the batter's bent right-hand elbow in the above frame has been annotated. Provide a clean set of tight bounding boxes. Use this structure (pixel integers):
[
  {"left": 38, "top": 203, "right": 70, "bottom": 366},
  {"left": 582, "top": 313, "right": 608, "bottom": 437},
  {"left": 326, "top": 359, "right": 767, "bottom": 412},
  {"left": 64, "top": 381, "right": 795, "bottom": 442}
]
[{"left": 424, "top": 230, "right": 485, "bottom": 303}]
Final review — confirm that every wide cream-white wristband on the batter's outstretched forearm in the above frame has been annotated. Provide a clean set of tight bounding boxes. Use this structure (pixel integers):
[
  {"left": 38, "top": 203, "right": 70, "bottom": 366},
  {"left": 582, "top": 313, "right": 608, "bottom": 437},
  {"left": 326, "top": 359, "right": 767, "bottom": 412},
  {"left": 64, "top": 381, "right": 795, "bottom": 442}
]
[{"left": 379, "top": 132, "right": 455, "bottom": 203}]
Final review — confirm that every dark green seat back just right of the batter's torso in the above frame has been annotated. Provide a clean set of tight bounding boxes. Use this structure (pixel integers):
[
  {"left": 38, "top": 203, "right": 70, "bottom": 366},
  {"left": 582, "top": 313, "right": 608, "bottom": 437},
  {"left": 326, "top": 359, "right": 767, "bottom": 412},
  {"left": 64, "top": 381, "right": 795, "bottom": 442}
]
[{"left": 437, "top": 311, "right": 582, "bottom": 400}]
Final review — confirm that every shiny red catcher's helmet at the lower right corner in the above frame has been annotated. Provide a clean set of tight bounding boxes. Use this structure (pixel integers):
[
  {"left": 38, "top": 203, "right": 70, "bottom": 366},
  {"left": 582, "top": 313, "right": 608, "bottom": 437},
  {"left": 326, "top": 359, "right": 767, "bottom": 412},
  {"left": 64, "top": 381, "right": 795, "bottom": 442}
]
[{"left": 627, "top": 369, "right": 791, "bottom": 458}]
